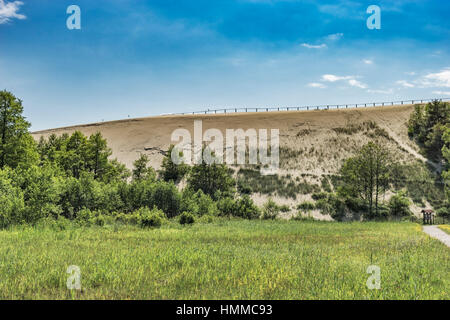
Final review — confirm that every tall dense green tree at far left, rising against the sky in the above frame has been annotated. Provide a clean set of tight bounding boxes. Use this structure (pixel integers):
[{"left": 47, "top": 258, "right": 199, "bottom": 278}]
[{"left": 0, "top": 90, "right": 38, "bottom": 169}]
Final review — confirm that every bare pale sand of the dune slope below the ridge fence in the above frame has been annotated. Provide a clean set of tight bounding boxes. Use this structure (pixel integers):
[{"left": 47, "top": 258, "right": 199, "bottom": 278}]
[{"left": 33, "top": 105, "right": 425, "bottom": 220}]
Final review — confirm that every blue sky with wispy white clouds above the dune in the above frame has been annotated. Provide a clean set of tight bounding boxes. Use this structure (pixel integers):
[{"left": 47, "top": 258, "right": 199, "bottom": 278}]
[{"left": 0, "top": 0, "right": 450, "bottom": 130}]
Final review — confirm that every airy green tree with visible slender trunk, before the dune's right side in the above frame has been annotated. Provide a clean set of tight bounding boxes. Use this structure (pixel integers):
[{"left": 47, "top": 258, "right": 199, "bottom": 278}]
[{"left": 341, "top": 142, "right": 390, "bottom": 217}]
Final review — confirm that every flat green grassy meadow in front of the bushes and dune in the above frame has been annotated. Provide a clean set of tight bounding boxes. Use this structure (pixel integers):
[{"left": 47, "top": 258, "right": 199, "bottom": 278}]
[{"left": 0, "top": 220, "right": 450, "bottom": 299}]
